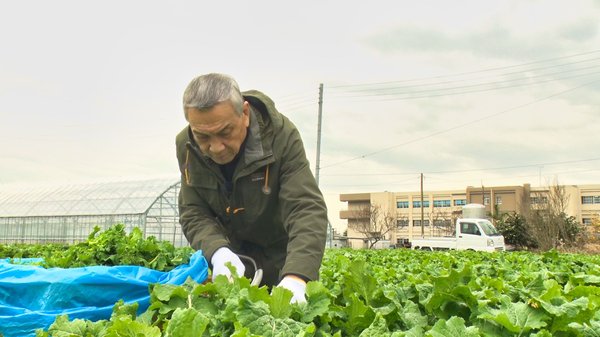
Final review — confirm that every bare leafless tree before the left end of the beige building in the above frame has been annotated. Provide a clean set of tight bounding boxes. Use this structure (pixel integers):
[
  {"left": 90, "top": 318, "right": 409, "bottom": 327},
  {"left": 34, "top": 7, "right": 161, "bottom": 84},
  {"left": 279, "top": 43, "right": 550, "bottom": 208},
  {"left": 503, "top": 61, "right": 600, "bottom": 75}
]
[{"left": 348, "top": 205, "right": 397, "bottom": 249}]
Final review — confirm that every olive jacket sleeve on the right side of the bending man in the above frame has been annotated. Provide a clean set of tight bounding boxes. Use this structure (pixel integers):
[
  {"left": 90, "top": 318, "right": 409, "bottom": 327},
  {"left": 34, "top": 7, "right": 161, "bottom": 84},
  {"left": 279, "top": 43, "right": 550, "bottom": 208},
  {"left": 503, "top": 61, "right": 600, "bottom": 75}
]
[{"left": 279, "top": 119, "right": 328, "bottom": 280}]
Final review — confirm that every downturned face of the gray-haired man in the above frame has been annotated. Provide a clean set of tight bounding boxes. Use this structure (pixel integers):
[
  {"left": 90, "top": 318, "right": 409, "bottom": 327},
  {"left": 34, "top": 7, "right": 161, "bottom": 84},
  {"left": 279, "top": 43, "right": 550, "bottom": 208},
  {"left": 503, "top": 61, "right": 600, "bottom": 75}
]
[{"left": 186, "top": 102, "right": 250, "bottom": 165}]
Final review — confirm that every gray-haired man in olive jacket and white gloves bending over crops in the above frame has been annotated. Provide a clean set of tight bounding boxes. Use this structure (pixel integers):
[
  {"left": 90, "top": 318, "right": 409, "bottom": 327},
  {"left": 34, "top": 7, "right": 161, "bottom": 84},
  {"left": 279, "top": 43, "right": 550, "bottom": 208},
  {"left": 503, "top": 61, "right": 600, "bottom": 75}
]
[{"left": 177, "top": 74, "right": 327, "bottom": 302}]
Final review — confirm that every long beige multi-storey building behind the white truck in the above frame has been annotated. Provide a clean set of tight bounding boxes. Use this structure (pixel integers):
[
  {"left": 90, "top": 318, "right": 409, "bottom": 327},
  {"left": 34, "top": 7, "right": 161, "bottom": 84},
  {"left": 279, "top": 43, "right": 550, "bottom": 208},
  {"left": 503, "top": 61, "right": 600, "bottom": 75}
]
[{"left": 340, "top": 184, "right": 600, "bottom": 248}]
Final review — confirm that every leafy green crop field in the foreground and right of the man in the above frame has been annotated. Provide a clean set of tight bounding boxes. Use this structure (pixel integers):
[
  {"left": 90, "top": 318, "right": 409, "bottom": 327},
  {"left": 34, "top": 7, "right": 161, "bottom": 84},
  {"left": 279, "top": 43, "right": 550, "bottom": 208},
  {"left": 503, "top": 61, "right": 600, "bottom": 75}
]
[{"left": 1, "top": 226, "right": 600, "bottom": 337}]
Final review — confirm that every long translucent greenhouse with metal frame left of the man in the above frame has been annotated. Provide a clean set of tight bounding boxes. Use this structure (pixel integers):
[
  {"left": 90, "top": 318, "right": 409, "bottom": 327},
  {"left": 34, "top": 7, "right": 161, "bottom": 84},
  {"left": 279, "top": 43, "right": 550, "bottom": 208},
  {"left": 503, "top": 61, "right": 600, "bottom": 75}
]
[{"left": 0, "top": 178, "right": 188, "bottom": 246}]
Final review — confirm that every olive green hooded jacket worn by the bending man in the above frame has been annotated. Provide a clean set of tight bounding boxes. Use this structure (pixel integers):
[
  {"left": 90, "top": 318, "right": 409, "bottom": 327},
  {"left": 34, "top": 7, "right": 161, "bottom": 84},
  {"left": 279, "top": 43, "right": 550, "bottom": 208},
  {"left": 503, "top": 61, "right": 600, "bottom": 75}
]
[{"left": 176, "top": 90, "right": 327, "bottom": 285}]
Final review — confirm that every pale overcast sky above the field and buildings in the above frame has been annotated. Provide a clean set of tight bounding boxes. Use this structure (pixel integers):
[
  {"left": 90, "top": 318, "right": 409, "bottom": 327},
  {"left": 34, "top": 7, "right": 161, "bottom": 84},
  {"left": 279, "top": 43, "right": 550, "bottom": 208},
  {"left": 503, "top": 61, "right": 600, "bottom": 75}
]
[{"left": 0, "top": 0, "right": 600, "bottom": 230}]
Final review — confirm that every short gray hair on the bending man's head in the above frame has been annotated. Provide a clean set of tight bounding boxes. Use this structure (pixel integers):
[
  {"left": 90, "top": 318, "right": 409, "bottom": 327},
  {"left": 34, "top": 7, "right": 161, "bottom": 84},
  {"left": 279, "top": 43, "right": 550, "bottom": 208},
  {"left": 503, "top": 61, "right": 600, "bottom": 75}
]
[{"left": 183, "top": 73, "right": 244, "bottom": 118}]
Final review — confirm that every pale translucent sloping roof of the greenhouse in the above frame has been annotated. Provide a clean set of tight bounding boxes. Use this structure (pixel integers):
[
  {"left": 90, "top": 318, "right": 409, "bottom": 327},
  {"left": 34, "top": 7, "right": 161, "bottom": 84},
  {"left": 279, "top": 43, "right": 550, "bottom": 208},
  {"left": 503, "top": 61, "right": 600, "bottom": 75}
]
[{"left": 0, "top": 178, "right": 179, "bottom": 217}]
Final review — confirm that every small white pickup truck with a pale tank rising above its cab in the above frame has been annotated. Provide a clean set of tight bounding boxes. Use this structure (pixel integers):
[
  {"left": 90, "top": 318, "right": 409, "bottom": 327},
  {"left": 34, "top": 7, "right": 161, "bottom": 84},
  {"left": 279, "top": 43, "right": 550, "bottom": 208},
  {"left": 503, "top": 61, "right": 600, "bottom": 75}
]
[{"left": 410, "top": 204, "right": 506, "bottom": 252}]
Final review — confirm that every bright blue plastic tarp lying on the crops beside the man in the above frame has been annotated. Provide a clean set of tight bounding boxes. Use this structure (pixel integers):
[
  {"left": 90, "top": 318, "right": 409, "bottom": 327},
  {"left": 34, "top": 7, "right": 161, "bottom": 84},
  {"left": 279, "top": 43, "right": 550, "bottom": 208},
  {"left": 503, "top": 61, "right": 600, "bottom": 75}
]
[{"left": 0, "top": 251, "right": 208, "bottom": 337}]
